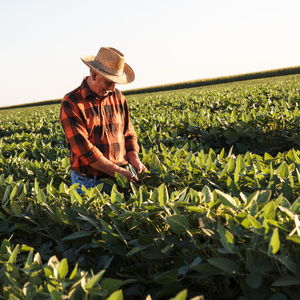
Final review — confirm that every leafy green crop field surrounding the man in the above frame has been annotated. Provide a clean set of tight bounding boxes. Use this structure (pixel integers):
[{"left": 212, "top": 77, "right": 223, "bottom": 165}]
[{"left": 0, "top": 75, "right": 300, "bottom": 300}]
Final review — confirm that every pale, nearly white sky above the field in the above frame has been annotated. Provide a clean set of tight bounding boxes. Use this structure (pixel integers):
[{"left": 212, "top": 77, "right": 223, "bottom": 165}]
[{"left": 0, "top": 0, "right": 300, "bottom": 106}]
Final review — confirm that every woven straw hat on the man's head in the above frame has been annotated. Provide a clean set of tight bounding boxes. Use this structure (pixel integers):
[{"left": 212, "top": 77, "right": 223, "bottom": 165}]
[{"left": 81, "top": 47, "right": 135, "bottom": 84}]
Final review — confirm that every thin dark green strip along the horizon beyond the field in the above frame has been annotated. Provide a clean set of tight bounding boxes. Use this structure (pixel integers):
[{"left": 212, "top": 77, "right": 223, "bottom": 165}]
[{"left": 0, "top": 66, "right": 300, "bottom": 110}]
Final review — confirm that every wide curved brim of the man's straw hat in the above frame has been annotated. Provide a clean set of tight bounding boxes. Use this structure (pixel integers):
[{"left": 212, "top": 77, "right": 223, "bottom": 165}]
[{"left": 81, "top": 55, "right": 135, "bottom": 84}]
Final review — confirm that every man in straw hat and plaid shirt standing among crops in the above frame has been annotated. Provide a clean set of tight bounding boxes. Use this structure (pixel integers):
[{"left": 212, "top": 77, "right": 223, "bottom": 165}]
[{"left": 60, "top": 47, "right": 146, "bottom": 192}]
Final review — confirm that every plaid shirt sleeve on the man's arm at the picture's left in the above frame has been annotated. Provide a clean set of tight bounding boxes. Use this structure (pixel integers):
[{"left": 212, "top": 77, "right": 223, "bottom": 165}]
[{"left": 60, "top": 96, "right": 103, "bottom": 165}]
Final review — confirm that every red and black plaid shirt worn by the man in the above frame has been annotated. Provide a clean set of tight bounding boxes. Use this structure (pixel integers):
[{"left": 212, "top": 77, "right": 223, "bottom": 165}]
[{"left": 60, "top": 77, "right": 139, "bottom": 176}]
